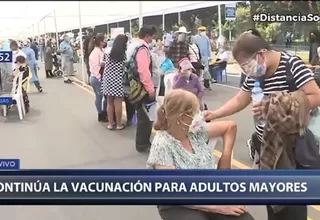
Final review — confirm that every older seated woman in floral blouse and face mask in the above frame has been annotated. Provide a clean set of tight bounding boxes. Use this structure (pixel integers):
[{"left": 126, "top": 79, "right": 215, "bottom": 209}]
[{"left": 147, "top": 89, "right": 253, "bottom": 220}]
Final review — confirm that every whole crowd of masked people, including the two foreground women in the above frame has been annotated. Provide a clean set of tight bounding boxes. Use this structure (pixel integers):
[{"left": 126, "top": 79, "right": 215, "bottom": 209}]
[{"left": 0, "top": 22, "right": 320, "bottom": 220}]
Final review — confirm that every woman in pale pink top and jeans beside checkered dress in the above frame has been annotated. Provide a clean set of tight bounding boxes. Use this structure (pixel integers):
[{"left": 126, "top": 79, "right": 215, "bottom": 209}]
[{"left": 89, "top": 35, "right": 108, "bottom": 122}]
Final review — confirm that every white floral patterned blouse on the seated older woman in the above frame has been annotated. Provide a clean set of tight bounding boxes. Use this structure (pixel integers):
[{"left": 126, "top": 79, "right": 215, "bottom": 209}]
[{"left": 147, "top": 123, "right": 215, "bottom": 169}]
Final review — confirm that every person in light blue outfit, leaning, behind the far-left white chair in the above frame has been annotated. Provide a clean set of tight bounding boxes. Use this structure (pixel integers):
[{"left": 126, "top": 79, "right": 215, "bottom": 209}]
[{"left": 22, "top": 41, "right": 42, "bottom": 92}]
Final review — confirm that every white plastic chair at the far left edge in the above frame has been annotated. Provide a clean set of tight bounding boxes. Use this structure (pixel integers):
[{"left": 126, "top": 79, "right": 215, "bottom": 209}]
[{"left": 1, "top": 72, "right": 27, "bottom": 120}]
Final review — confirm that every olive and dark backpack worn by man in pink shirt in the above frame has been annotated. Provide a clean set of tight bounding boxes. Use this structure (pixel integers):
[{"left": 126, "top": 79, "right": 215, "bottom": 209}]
[{"left": 123, "top": 45, "right": 152, "bottom": 104}]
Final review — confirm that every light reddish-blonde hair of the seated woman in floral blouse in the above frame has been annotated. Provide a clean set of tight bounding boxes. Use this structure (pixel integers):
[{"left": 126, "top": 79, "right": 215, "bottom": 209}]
[{"left": 154, "top": 89, "right": 199, "bottom": 131}]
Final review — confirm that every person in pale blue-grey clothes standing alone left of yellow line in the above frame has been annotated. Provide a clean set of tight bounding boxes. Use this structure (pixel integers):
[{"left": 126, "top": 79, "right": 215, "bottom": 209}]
[{"left": 59, "top": 35, "right": 74, "bottom": 83}]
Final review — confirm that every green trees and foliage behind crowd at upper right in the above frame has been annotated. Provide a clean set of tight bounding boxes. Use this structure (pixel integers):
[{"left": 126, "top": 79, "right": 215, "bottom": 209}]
[{"left": 128, "top": 1, "right": 320, "bottom": 42}]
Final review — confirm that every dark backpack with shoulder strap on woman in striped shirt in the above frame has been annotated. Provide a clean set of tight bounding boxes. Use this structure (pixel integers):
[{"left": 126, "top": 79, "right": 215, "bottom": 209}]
[{"left": 258, "top": 54, "right": 320, "bottom": 169}]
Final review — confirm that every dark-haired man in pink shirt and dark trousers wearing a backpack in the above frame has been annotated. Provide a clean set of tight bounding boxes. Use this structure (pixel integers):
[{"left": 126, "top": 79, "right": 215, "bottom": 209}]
[{"left": 127, "top": 26, "right": 157, "bottom": 153}]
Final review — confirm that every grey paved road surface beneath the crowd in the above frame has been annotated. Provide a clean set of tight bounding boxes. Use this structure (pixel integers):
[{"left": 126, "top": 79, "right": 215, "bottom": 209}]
[{"left": 0, "top": 64, "right": 320, "bottom": 220}]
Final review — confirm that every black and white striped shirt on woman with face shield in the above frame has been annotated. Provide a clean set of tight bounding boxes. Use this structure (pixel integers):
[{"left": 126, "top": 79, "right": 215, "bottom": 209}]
[{"left": 242, "top": 52, "right": 314, "bottom": 141}]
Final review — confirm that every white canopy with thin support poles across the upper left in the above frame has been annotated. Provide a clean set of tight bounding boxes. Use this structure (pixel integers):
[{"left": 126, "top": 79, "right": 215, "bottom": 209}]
[{"left": 0, "top": 1, "right": 240, "bottom": 84}]
